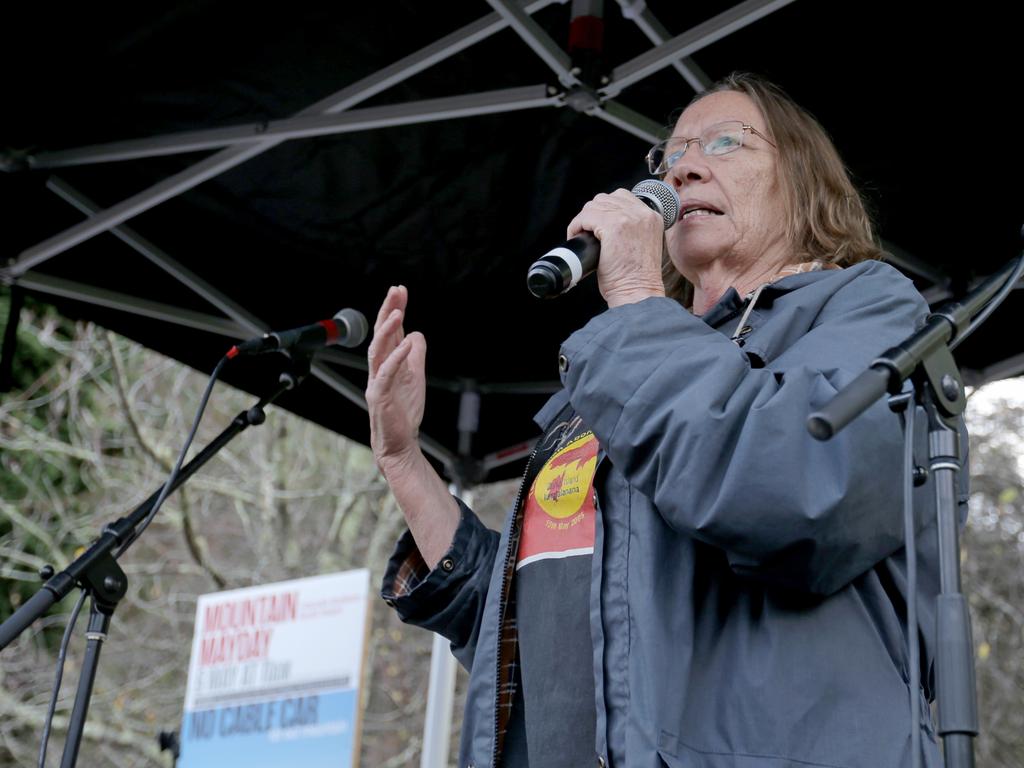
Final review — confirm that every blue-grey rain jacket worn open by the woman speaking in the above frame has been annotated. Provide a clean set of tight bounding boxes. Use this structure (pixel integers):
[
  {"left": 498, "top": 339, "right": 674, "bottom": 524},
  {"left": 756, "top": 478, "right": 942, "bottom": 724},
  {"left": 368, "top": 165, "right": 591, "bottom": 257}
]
[{"left": 382, "top": 262, "right": 967, "bottom": 768}]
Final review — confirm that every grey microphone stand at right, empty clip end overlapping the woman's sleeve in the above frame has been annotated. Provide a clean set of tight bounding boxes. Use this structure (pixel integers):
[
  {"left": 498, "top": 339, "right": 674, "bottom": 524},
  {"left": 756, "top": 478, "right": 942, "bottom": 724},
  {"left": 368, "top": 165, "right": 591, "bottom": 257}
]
[{"left": 807, "top": 256, "right": 1024, "bottom": 768}]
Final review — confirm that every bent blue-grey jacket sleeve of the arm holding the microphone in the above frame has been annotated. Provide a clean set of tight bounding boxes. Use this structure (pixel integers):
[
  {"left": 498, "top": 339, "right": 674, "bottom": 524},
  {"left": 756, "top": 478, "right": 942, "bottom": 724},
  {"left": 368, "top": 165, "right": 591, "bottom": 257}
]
[{"left": 562, "top": 269, "right": 927, "bottom": 594}]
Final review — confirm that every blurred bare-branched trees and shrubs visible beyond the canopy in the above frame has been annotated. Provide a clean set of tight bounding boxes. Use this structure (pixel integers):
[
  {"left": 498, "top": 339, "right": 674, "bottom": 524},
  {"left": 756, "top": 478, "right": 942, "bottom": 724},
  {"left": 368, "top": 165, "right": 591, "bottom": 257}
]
[{"left": 0, "top": 295, "right": 1024, "bottom": 768}]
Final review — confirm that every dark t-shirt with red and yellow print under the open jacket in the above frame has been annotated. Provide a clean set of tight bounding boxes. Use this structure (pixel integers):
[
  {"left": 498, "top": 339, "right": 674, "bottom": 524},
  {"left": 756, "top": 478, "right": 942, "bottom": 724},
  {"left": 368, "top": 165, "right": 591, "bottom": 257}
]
[{"left": 515, "top": 416, "right": 598, "bottom": 768}]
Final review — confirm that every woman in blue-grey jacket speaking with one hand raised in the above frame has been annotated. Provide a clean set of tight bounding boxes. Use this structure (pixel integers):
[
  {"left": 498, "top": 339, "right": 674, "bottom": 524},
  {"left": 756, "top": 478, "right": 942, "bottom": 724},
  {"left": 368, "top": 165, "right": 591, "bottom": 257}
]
[{"left": 367, "top": 75, "right": 940, "bottom": 768}]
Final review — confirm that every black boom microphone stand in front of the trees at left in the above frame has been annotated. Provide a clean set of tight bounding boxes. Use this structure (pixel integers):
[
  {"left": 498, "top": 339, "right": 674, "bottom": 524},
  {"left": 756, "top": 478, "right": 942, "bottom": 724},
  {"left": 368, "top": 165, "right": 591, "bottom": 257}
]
[{"left": 0, "top": 353, "right": 310, "bottom": 768}]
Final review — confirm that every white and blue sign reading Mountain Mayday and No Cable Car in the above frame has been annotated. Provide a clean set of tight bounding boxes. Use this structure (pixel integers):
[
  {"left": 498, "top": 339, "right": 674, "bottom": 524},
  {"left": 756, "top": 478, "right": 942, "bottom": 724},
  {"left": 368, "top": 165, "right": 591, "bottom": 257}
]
[{"left": 178, "top": 569, "right": 370, "bottom": 768}]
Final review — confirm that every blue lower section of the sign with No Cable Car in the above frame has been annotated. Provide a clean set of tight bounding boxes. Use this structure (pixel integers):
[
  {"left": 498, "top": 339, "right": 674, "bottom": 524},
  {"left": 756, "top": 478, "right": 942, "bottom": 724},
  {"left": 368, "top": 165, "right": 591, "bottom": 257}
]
[{"left": 178, "top": 688, "right": 357, "bottom": 768}]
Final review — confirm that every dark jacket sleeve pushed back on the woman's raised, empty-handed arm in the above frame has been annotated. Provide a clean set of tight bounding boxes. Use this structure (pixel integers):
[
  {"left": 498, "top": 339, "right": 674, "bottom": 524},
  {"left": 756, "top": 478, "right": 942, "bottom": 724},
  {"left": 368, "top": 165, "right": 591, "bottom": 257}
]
[{"left": 381, "top": 499, "right": 499, "bottom": 670}]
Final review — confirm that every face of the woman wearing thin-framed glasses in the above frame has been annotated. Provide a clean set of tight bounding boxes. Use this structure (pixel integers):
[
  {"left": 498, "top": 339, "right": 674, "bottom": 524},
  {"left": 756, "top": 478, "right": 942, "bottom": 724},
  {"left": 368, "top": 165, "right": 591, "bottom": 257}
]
[{"left": 665, "top": 91, "right": 786, "bottom": 284}]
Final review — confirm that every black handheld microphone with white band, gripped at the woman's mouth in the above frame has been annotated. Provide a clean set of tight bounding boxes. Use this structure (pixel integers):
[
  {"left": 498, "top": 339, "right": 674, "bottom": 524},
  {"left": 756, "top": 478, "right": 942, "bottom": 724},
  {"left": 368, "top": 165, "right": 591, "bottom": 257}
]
[{"left": 526, "top": 178, "right": 679, "bottom": 299}]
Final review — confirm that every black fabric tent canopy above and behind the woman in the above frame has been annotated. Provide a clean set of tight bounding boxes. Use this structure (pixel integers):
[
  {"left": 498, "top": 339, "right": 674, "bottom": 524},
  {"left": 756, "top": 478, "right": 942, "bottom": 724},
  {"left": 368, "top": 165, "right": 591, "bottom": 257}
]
[{"left": 0, "top": 0, "right": 1024, "bottom": 482}]
